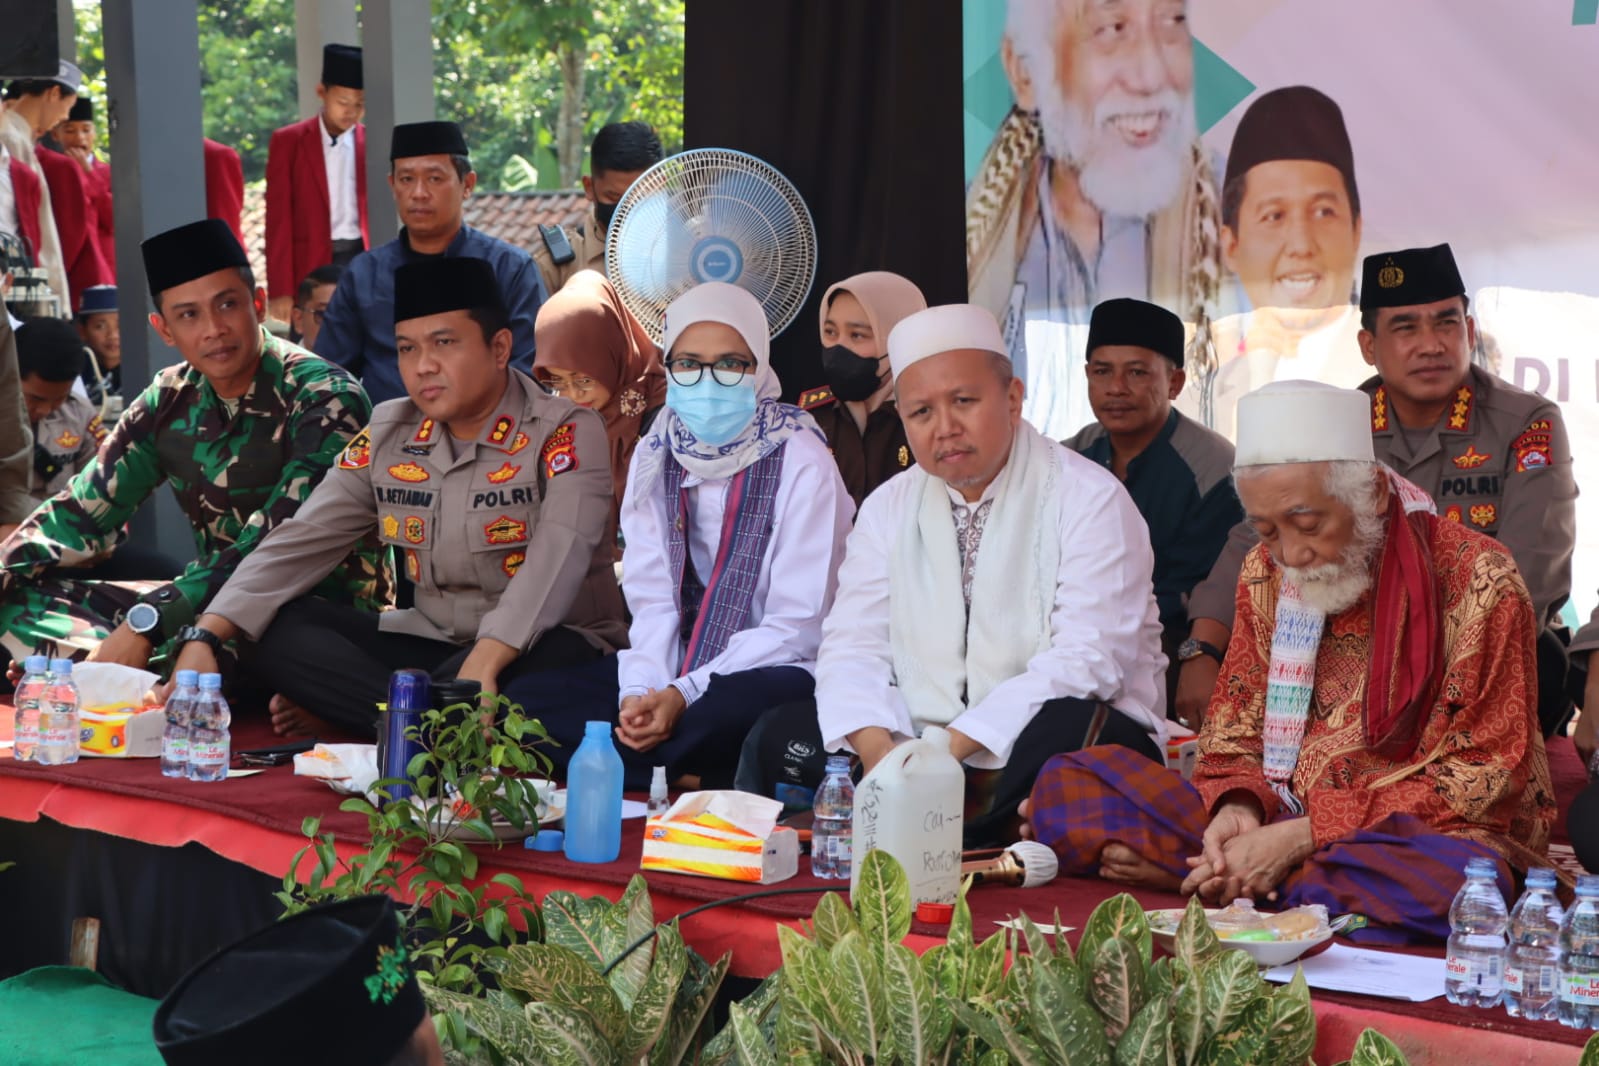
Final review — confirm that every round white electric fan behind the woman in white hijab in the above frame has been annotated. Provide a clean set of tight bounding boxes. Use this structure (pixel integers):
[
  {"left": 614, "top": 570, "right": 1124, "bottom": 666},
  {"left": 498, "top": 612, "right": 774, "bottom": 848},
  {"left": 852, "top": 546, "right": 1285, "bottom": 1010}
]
[{"left": 604, "top": 149, "right": 815, "bottom": 344}]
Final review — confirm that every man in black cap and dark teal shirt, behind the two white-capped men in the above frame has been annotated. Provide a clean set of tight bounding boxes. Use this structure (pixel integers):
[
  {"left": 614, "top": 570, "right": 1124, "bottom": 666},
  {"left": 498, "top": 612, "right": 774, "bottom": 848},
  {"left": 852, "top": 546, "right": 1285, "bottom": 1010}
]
[{"left": 1065, "top": 299, "right": 1244, "bottom": 713}]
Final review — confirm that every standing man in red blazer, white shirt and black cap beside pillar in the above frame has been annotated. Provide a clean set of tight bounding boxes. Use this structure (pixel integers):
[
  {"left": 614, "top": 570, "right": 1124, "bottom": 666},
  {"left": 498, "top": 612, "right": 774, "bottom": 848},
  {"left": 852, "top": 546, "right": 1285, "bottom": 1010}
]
[{"left": 267, "top": 45, "right": 368, "bottom": 321}]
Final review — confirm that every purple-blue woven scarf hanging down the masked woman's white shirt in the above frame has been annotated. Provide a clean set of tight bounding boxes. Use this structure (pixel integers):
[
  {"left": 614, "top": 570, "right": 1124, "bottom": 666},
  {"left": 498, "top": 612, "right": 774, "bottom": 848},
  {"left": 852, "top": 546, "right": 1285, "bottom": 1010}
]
[{"left": 662, "top": 444, "right": 787, "bottom": 678}]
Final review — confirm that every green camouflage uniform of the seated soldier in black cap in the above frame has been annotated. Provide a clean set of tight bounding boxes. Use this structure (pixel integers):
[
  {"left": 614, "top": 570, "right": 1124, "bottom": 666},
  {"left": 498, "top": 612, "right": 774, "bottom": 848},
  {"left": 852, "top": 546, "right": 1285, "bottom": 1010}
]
[{"left": 0, "top": 331, "right": 393, "bottom": 655}]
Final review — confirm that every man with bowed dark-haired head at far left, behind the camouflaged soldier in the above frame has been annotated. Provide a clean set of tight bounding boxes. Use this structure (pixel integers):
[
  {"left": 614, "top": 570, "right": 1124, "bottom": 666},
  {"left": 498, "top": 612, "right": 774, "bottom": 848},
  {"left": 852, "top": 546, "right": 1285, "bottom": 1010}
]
[{"left": 16, "top": 318, "right": 106, "bottom": 507}]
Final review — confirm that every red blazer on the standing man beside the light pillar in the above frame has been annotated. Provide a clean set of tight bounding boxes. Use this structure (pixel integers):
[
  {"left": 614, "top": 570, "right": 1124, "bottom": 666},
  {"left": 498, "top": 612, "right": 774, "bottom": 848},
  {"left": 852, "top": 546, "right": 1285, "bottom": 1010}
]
[{"left": 267, "top": 115, "right": 371, "bottom": 299}]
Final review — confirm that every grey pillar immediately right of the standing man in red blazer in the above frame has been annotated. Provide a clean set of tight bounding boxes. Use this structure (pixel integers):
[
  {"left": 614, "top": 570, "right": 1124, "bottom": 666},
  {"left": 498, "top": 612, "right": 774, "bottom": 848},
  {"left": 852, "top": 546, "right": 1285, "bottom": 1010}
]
[{"left": 361, "top": 0, "right": 433, "bottom": 248}]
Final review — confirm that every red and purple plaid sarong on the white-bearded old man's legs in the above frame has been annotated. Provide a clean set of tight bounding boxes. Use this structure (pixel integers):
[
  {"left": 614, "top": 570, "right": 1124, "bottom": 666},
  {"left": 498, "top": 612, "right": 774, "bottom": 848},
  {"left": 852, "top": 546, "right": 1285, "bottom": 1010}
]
[{"left": 1030, "top": 746, "right": 1514, "bottom": 945}]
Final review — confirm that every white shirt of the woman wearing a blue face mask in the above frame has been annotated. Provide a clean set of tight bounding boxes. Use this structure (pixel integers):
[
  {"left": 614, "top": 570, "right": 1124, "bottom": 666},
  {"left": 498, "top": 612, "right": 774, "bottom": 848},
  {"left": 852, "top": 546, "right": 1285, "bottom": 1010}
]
[{"left": 617, "top": 432, "right": 855, "bottom": 703}]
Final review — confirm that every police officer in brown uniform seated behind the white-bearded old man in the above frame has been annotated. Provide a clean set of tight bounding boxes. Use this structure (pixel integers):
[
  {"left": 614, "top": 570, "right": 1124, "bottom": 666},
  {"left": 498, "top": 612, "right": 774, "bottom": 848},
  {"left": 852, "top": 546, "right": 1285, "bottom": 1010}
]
[{"left": 1178, "top": 245, "right": 1577, "bottom": 735}]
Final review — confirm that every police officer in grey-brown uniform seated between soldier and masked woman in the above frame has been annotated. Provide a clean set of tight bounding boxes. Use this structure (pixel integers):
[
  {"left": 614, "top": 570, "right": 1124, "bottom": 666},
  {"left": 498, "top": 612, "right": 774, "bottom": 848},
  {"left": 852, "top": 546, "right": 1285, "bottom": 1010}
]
[{"left": 177, "top": 257, "right": 627, "bottom": 734}]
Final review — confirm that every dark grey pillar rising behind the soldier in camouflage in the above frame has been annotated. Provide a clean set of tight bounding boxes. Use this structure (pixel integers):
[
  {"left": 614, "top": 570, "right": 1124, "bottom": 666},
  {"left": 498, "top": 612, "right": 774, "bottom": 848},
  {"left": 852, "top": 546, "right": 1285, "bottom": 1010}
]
[{"left": 101, "top": 0, "right": 205, "bottom": 559}]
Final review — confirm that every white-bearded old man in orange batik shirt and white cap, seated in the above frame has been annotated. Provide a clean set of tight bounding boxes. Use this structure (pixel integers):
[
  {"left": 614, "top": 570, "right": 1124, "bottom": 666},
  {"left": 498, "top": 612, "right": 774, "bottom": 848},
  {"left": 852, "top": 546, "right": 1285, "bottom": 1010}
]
[{"left": 1025, "top": 382, "right": 1554, "bottom": 943}]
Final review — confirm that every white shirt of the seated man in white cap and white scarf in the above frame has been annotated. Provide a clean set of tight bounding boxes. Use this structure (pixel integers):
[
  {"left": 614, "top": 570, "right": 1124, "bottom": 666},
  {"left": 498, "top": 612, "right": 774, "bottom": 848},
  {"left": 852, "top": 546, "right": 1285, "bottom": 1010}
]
[{"left": 815, "top": 447, "right": 1166, "bottom": 769}]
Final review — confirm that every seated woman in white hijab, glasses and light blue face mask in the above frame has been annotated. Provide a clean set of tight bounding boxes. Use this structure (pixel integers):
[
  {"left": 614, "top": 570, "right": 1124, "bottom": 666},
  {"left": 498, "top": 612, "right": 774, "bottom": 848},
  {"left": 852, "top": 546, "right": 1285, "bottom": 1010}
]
[{"left": 512, "top": 283, "right": 855, "bottom": 788}]
